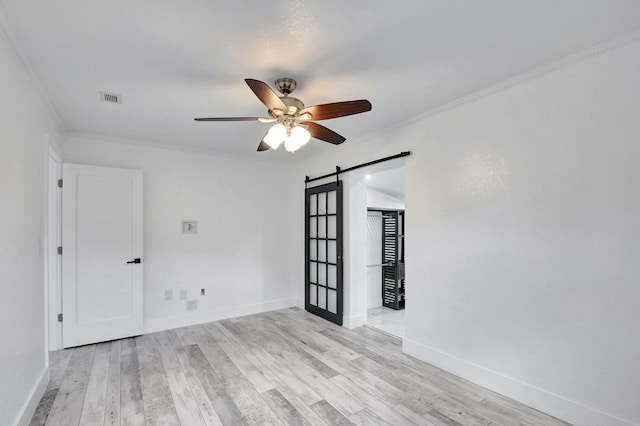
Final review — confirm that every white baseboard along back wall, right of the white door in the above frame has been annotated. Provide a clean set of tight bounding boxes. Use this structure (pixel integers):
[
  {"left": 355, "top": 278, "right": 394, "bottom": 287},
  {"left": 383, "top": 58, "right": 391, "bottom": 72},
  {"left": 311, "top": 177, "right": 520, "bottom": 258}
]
[{"left": 144, "top": 298, "right": 298, "bottom": 334}]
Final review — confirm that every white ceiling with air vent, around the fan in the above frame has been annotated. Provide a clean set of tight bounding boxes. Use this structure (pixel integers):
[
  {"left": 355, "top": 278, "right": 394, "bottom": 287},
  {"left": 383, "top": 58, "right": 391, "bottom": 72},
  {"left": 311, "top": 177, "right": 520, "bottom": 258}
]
[{"left": 0, "top": 0, "right": 640, "bottom": 161}]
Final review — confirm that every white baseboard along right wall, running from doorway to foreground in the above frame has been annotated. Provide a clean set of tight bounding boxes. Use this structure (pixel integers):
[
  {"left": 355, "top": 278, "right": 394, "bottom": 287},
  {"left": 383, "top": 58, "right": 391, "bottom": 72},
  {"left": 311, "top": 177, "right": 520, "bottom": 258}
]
[{"left": 402, "top": 338, "right": 637, "bottom": 426}]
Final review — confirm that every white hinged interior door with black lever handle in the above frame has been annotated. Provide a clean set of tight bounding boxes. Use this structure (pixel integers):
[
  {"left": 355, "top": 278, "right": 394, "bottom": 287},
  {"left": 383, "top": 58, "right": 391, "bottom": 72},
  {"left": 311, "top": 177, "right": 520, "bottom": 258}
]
[{"left": 62, "top": 164, "right": 143, "bottom": 348}]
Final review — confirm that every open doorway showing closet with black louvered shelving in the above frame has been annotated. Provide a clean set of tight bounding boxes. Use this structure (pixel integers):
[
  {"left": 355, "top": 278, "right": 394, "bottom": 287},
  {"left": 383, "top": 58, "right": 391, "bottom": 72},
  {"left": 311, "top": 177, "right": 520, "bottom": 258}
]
[{"left": 365, "top": 167, "right": 406, "bottom": 338}]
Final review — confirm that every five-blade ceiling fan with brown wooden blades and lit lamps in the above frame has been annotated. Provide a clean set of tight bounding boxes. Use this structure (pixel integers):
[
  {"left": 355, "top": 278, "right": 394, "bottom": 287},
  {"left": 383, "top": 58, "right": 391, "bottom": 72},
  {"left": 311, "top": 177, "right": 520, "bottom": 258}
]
[{"left": 195, "top": 78, "right": 371, "bottom": 152}]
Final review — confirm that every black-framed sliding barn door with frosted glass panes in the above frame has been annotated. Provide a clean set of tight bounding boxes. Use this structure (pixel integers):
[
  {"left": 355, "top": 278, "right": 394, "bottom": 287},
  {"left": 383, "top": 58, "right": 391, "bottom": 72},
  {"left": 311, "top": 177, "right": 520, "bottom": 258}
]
[{"left": 305, "top": 181, "right": 342, "bottom": 325}]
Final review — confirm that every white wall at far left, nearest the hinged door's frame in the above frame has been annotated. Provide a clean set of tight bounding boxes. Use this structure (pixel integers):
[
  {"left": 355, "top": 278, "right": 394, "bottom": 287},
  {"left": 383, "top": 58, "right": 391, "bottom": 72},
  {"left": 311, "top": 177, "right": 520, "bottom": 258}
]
[{"left": 0, "top": 22, "right": 60, "bottom": 425}]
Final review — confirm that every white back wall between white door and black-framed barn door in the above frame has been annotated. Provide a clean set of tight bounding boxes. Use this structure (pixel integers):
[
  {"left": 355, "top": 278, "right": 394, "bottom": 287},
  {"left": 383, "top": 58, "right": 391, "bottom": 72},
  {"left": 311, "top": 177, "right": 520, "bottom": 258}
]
[{"left": 63, "top": 136, "right": 296, "bottom": 331}]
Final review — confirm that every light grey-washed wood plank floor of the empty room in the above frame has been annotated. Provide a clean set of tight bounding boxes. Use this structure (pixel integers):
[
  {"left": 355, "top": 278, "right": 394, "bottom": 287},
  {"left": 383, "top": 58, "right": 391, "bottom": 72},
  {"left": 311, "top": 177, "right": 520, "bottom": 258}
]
[{"left": 31, "top": 308, "right": 566, "bottom": 426}]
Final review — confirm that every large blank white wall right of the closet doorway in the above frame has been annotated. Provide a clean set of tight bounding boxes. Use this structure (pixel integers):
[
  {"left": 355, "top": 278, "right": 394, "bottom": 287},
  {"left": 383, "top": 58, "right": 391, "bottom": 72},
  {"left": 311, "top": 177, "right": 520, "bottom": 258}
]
[{"left": 292, "top": 36, "right": 640, "bottom": 425}]
